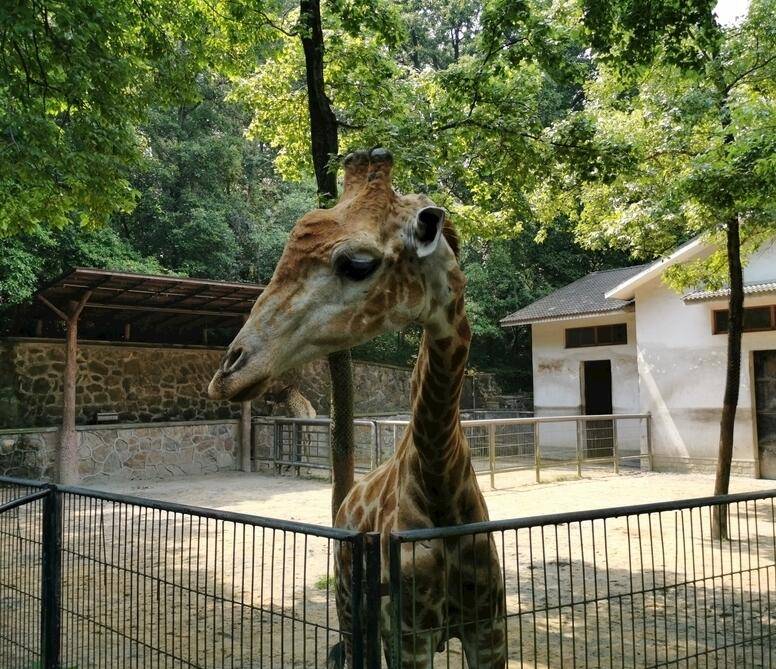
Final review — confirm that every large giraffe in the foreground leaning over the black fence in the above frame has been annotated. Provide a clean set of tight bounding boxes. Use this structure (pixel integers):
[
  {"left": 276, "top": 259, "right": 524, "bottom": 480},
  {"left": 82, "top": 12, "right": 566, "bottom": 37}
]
[{"left": 208, "top": 149, "right": 506, "bottom": 669}]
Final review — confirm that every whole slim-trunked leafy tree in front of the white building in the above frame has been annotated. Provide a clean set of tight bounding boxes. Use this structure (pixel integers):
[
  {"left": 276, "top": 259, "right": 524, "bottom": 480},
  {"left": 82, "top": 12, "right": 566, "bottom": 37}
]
[{"left": 536, "top": 0, "right": 776, "bottom": 536}]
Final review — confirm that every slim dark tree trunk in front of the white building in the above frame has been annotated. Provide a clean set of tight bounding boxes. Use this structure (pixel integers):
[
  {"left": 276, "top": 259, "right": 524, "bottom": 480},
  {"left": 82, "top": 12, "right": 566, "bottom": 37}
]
[{"left": 713, "top": 217, "right": 744, "bottom": 539}]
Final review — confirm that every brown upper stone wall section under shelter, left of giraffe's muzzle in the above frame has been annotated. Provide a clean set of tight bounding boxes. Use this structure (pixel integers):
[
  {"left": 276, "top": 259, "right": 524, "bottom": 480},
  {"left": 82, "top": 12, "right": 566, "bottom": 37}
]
[{"left": 0, "top": 340, "right": 239, "bottom": 428}]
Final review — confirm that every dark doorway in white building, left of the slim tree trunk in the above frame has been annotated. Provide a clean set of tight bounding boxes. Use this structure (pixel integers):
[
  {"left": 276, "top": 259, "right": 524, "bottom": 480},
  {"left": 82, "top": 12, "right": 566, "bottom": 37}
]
[{"left": 582, "top": 360, "right": 614, "bottom": 458}]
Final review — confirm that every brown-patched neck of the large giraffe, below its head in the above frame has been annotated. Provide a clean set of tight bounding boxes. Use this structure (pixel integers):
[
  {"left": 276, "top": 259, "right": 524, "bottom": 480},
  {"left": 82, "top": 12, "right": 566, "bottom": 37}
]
[{"left": 410, "top": 297, "right": 471, "bottom": 477}]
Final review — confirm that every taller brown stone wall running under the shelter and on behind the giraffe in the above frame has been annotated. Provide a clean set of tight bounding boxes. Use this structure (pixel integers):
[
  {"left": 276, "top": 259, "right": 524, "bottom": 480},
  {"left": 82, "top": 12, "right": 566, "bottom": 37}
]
[{"left": 0, "top": 339, "right": 493, "bottom": 428}]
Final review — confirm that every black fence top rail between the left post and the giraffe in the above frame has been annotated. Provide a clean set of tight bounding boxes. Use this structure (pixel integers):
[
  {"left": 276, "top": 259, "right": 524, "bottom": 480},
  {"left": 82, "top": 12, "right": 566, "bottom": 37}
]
[{"left": 52, "top": 485, "right": 360, "bottom": 541}]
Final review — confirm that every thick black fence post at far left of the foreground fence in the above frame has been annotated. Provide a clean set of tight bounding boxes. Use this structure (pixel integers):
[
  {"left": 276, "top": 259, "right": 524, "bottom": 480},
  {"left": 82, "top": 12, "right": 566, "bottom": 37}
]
[{"left": 40, "top": 486, "right": 62, "bottom": 669}]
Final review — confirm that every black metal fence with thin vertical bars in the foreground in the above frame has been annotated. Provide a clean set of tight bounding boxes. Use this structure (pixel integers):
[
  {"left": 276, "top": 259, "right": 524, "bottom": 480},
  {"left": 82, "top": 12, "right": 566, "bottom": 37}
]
[{"left": 0, "top": 472, "right": 776, "bottom": 669}]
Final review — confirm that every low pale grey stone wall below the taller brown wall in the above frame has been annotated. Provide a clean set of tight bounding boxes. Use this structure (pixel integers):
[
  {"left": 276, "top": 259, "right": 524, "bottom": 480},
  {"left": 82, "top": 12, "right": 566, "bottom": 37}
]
[{"left": 0, "top": 420, "right": 240, "bottom": 483}]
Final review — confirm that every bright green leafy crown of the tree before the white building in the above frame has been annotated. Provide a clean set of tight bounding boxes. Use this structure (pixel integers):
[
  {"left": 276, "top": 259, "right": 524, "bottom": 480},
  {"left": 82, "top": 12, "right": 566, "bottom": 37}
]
[{"left": 534, "top": 0, "right": 776, "bottom": 286}]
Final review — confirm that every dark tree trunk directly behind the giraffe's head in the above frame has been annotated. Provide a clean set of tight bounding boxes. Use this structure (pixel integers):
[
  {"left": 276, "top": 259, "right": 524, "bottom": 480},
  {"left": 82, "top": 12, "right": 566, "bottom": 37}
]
[{"left": 299, "top": 0, "right": 354, "bottom": 523}]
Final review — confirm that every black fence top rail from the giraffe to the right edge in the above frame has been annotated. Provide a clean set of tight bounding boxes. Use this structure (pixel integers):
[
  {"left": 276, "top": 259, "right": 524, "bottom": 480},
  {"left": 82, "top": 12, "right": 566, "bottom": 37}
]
[{"left": 391, "top": 489, "right": 776, "bottom": 543}]
